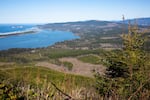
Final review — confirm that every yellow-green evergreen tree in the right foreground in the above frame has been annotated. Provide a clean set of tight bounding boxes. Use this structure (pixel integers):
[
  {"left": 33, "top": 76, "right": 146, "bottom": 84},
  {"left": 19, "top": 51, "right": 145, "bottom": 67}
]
[{"left": 96, "top": 20, "right": 150, "bottom": 100}]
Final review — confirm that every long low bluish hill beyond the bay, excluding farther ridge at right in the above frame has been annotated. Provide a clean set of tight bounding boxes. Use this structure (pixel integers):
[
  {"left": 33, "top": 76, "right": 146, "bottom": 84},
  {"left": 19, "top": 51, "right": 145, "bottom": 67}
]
[{"left": 38, "top": 20, "right": 120, "bottom": 31}]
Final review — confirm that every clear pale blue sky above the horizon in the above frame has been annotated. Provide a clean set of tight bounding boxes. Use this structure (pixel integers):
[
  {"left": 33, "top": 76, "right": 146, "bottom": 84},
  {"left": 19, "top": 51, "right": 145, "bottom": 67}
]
[{"left": 0, "top": 0, "right": 150, "bottom": 23}]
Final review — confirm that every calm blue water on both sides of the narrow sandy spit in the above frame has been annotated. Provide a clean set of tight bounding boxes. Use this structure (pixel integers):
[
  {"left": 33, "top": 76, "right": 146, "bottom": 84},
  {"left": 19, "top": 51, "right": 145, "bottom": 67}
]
[{"left": 0, "top": 25, "right": 79, "bottom": 50}]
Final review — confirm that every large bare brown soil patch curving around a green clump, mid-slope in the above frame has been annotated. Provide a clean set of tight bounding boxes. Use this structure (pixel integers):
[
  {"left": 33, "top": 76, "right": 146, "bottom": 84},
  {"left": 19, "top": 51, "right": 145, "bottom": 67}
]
[{"left": 36, "top": 58, "right": 106, "bottom": 77}]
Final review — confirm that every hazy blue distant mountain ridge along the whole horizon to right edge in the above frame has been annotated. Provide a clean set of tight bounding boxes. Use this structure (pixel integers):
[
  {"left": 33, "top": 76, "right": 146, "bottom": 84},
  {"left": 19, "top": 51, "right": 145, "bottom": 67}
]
[{"left": 38, "top": 17, "right": 150, "bottom": 30}]
